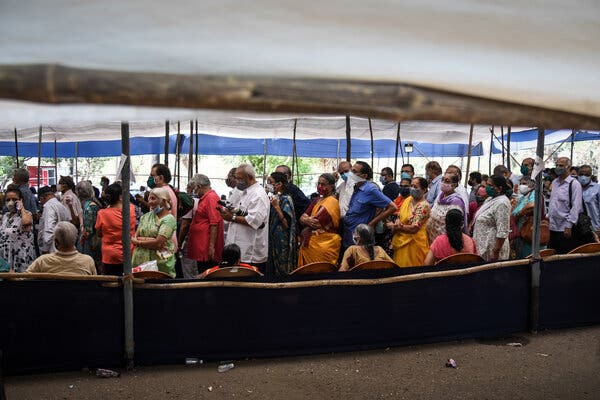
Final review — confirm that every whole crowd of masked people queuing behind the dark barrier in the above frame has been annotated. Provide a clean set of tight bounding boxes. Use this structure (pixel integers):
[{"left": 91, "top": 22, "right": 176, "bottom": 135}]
[{"left": 0, "top": 157, "right": 600, "bottom": 278}]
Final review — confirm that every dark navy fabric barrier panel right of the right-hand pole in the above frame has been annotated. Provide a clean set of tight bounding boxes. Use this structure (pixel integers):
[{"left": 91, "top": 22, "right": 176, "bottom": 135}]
[{"left": 539, "top": 256, "right": 600, "bottom": 329}]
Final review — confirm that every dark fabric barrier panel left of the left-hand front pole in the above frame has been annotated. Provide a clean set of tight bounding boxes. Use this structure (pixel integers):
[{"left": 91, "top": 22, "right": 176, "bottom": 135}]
[{"left": 0, "top": 280, "right": 124, "bottom": 374}]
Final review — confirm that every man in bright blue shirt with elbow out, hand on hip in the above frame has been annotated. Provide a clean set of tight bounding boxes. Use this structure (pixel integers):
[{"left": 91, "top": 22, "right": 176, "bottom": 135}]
[{"left": 342, "top": 161, "right": 397, "bottom": 249}]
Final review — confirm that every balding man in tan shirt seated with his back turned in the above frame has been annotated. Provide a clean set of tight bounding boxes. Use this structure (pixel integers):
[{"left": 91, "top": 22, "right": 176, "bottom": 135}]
[{"left": 26, "top": 221, "right": 96, "bottom": 275}]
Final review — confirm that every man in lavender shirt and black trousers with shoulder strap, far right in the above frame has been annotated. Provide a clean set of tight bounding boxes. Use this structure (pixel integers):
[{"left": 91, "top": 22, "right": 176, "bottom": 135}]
[{"left": 548, "top": 157, "right": 582, "bottom": 254}]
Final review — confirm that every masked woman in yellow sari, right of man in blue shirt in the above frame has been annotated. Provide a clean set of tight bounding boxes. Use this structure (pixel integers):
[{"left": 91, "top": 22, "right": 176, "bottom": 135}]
[{"left": 387, "top": 178, "right": 430, "bottom": 267}]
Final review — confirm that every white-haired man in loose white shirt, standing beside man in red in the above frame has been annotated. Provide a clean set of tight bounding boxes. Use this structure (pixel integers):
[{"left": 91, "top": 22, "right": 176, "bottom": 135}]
[{"left": 220, "top": 164, "right": 270, "bottom": 271}]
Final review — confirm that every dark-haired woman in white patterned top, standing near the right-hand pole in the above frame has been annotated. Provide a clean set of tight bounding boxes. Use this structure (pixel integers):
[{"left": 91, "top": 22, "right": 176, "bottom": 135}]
[{"left": 473, "top": 175, "right": 512, "bottom": 261}]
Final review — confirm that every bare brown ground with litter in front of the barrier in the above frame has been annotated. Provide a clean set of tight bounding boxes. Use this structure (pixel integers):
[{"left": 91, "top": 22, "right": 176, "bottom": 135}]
[{"left": 6, "top": 327, "right": 600, "bottom": 400}]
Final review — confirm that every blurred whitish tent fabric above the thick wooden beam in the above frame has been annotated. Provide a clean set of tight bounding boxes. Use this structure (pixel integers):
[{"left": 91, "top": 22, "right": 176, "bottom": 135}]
[{"left": 0, "top": 0, "right": 600, "bottom": 121}]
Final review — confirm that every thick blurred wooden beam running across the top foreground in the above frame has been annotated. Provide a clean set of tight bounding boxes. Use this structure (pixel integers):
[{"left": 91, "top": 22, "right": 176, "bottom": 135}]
[{"left": 0, "top": 64, "right": 600, "bottom": 129}]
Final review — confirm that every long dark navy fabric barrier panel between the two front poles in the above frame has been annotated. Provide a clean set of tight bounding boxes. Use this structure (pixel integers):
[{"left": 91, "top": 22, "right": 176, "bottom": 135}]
[{"left": 133, "top": 265, "right": 530, "bottom": 364}]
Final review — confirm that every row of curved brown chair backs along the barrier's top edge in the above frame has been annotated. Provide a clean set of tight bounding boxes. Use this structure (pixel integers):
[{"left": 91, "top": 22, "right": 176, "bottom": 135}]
[{"left": 134, "top": 243, "right": 600, "bottom": 280}]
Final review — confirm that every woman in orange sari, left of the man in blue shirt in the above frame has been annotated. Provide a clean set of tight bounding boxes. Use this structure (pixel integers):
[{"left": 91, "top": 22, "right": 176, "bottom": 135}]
[{"left": 298, "top": 174, "right": 342, "bottom": 267}]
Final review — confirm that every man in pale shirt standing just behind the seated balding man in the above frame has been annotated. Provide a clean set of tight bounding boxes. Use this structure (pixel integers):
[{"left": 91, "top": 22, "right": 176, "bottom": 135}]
[{"left": 38, "top": 186, "right": 71, "bottom": 254}]
